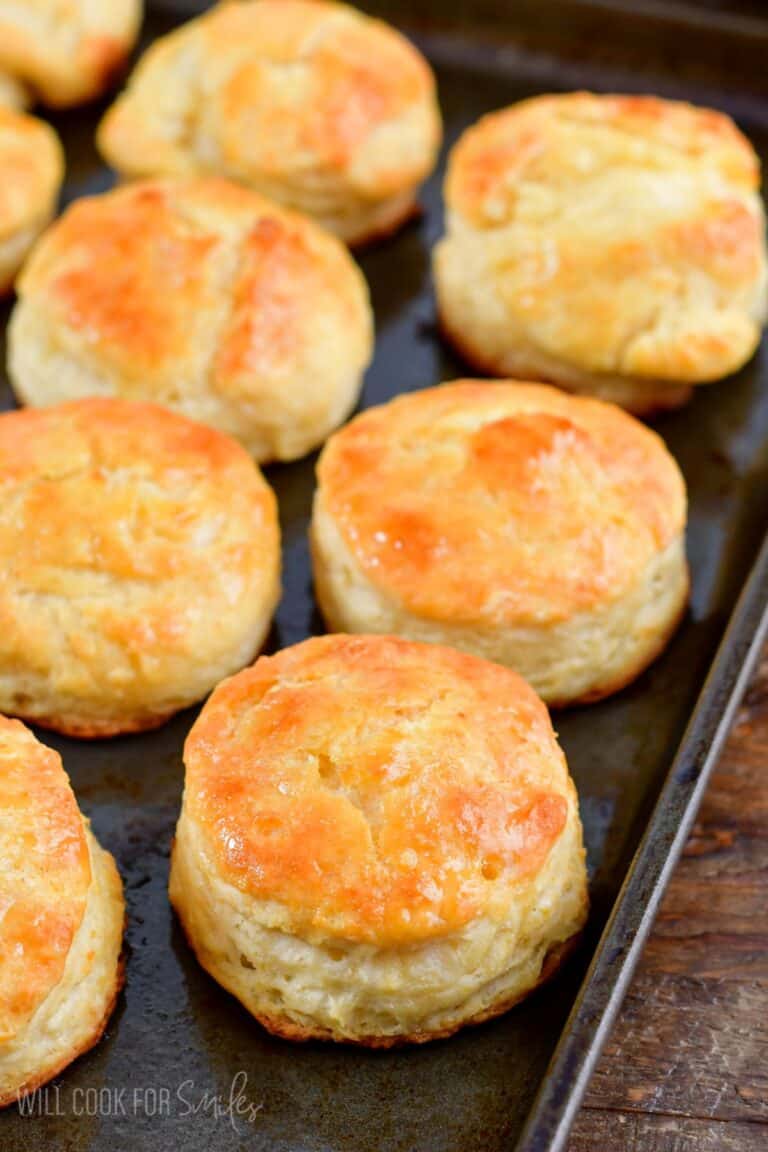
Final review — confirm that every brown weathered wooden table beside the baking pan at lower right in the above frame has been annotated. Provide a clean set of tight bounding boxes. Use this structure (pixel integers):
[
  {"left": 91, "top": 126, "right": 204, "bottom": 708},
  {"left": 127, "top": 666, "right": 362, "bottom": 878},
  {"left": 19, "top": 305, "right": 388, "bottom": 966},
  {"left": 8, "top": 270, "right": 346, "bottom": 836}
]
[{"left": 569, "top": 649, "right": 768, "bottom": 1152}]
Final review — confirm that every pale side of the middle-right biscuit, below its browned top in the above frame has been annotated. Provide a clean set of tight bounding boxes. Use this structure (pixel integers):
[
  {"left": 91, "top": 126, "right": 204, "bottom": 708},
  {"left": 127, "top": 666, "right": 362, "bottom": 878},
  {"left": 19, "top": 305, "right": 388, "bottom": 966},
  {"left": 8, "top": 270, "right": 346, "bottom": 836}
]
[{"left": 311, "top": 493, "right": 690, "bottom": 706}]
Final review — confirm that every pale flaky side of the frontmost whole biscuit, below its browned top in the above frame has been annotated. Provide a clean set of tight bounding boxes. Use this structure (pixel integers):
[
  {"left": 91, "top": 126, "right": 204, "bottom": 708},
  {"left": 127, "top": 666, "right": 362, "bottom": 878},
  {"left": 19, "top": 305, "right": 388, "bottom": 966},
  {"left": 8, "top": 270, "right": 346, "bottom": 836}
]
[{"left": 169, "top": 802, "right": 588, "bottom": 1048}]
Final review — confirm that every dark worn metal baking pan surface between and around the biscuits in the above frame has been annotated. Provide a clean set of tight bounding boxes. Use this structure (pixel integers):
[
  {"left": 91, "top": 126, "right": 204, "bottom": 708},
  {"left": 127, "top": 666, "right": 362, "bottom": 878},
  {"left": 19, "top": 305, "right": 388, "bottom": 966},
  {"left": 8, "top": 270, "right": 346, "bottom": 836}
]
[{"left": 0, "top": 0, "right": 768, "bottom": 1152}]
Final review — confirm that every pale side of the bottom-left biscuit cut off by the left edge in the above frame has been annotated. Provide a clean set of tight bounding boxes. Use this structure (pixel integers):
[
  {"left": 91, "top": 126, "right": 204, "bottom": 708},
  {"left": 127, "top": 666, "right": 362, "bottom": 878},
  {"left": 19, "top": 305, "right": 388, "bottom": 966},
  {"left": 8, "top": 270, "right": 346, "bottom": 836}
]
[{"left": 0, "top": 826, "right": 126, "bottom": 1107}]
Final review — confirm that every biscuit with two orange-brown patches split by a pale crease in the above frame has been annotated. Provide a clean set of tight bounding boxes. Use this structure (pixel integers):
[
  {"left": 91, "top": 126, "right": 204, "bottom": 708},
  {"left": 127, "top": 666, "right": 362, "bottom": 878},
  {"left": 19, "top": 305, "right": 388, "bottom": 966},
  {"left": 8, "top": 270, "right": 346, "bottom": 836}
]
[{"left": 8, "top": 177, "right": 373, "bottom": 461}]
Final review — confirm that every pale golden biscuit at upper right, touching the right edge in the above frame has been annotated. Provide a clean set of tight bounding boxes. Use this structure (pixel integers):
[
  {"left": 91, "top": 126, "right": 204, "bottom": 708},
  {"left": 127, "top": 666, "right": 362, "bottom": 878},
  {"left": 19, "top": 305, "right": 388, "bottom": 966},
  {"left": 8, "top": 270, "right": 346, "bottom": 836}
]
[{"left": 434, "top": 92, "right": 766, "bottom": 414}]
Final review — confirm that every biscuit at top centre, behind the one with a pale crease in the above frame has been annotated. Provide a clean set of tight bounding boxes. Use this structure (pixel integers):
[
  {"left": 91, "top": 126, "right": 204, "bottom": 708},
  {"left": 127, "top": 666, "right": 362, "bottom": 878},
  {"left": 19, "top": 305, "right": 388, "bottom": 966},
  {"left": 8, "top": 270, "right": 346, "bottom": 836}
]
[{"left": 98, "top": 0, "right": 442, "bottom": 244}]
